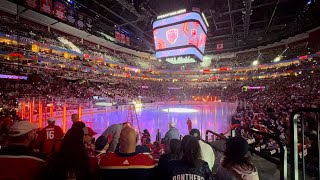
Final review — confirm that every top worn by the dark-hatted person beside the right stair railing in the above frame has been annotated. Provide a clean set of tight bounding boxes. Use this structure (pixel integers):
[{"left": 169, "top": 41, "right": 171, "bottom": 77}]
[{"left": 216, "top": 165, "right": 259, "bottom": 180}]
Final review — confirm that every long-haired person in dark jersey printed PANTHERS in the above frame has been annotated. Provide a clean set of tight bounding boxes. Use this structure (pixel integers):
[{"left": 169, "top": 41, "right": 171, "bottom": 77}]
[{"left": 165, "top": 135, "right": 213, "bottom": 180}]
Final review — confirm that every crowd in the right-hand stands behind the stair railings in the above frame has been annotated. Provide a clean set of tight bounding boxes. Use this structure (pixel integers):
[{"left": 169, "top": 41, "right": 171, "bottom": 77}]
[{"left": 232, "top": 74, "right": 320, "bottom": 173}]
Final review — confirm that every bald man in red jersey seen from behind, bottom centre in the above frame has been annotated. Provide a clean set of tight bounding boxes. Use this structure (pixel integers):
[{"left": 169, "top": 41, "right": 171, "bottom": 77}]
[{"left": 100, "top": 127, "right": 155, "bottom": 180}]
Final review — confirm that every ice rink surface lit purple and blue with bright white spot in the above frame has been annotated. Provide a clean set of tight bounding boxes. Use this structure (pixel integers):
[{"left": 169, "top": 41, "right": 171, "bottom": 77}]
[{"left": 56, "top": 102, "right": 236, "bottom": 141}]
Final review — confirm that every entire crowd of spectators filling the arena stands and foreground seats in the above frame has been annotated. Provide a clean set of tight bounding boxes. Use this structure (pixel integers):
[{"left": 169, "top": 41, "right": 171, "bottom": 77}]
[{"left": 0, "top": 9, "right": 320, "bottom": 179}]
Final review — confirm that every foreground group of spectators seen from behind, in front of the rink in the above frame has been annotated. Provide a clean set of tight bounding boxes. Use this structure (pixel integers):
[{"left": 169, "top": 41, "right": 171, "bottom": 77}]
[{"left": 0, "top": 109, "right": 259, "bottom": 180}]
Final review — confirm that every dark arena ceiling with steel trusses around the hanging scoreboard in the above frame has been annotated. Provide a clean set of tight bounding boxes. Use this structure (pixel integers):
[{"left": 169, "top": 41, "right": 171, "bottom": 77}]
[{"left": 32, "top": 0, "right": 320, "bottom": 54}]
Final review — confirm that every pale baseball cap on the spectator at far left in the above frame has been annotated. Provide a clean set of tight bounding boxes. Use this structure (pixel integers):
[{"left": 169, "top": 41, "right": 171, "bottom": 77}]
[{"left": 9, "top": 121, "right": 38, "bottom": 137}]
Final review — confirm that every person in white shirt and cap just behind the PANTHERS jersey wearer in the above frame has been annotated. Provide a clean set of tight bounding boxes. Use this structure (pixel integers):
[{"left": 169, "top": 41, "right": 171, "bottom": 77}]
[{"left": 189, "top": 129, "right": 215, "bottom": 171}]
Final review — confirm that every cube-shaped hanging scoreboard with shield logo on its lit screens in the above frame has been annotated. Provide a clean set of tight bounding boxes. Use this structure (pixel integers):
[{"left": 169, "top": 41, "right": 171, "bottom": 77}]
[{"left": 153, "top": 12, "right": 208, "bottom": 63}]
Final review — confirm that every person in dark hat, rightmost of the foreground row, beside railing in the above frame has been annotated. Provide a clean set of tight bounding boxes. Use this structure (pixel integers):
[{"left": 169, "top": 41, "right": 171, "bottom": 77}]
[{"left": 216, "top": 137, "right": 259, "bottom": 180}]
